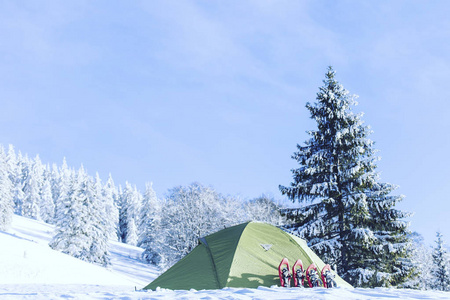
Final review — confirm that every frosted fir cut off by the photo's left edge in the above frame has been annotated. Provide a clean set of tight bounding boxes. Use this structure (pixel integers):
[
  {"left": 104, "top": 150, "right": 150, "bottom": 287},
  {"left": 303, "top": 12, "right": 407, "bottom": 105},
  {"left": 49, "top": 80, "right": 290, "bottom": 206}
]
[{"left": 0, "top": 145, "right": 14, "bottom": 230}]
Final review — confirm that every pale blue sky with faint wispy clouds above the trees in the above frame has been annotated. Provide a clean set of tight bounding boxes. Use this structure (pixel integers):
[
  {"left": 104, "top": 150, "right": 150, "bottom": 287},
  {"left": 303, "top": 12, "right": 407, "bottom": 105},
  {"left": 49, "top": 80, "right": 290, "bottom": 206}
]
[{"left": 0, "top": 0, "right": 450, "bottom": 243}]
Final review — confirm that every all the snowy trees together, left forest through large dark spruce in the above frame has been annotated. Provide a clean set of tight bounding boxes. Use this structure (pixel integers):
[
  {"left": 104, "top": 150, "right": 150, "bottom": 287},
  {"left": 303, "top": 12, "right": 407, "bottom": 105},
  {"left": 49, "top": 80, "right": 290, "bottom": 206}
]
[{"left": 0, "top": 68, "right": 450, "bottom": 291}]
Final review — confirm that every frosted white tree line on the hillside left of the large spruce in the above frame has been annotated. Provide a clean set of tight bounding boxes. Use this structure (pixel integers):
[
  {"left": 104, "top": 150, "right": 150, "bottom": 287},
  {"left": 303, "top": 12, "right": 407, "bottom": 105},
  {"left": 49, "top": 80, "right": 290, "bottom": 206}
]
[{"left": 0, "top": 145, "right": 286, "bottom": 270}]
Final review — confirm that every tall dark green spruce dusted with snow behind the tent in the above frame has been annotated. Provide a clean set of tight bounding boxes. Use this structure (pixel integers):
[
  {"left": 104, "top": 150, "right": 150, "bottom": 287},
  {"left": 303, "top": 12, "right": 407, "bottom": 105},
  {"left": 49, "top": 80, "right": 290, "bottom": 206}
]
[{"left": 280, "top": 67, "right": 411, "bottom": 286}]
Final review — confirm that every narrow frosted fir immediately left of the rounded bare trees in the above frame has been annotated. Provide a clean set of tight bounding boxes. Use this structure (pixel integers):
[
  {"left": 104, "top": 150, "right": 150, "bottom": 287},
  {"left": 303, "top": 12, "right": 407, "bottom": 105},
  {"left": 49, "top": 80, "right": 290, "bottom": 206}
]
[{"left": 137, "top": 183, "right": 161, "bottom": 265}]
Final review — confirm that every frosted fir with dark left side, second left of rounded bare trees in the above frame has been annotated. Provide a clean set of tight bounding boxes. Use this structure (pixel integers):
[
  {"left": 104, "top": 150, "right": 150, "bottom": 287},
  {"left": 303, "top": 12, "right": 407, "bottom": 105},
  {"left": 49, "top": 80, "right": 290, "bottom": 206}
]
[{"left": 119, "top": 182, "right": 142, "bottom": 245}]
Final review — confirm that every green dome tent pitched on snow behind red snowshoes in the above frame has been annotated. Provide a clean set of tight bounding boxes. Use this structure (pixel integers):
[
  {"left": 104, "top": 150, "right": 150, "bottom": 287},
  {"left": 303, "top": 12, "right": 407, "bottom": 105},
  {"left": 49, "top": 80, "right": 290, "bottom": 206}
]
[{"left": 144, "top": 222, "right": 351, "bottom": 290}]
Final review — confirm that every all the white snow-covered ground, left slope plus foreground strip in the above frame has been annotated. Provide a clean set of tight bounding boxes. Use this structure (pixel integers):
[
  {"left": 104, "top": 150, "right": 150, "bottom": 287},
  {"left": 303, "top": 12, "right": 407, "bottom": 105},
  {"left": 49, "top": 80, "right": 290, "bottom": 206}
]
[{"left": 0, "top": 216, "right": 450, "bottom": 300}]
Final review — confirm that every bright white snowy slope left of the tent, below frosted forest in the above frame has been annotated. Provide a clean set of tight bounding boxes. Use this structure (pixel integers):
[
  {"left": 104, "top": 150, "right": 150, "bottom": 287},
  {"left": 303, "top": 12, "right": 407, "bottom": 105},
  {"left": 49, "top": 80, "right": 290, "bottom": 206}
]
[{"left": 0, "top": 215, "right": 158, "bottom": 289}]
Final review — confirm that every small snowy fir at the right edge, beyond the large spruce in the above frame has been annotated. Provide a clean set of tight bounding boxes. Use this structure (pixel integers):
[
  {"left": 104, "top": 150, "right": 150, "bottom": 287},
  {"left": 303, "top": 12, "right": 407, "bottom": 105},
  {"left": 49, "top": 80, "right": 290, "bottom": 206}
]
[{"left": 431, "top": 232, "right": 450, "bottom": 291}]
